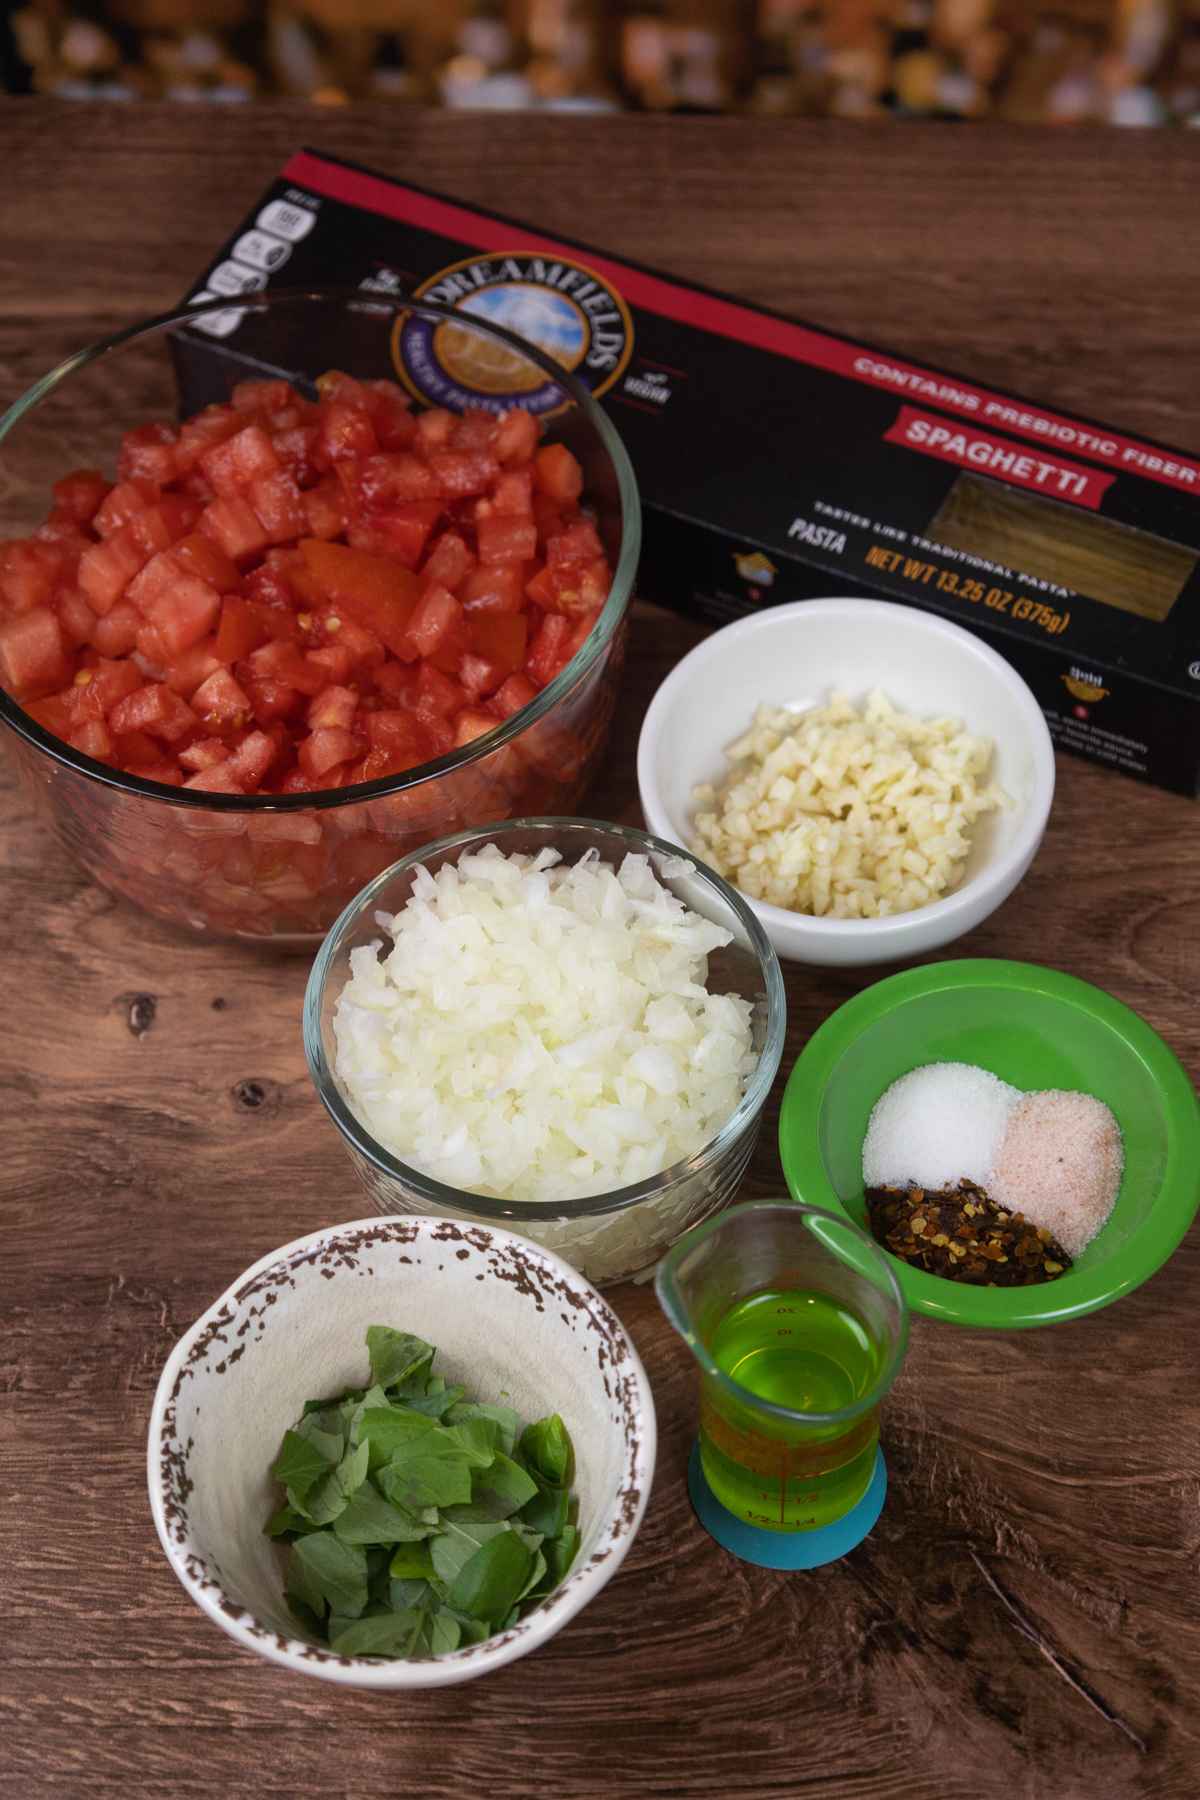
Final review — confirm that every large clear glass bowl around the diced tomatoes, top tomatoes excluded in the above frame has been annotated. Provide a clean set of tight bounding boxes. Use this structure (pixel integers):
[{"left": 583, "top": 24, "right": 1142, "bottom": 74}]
[{"left": 0, "top": 290, "right": 640, "bottom": 945}]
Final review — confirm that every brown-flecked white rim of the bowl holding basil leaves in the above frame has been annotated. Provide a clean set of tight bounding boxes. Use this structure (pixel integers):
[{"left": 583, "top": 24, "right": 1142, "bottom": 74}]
[{"left": 146, "top": 1213, "right": 658, "bottom": 1688}]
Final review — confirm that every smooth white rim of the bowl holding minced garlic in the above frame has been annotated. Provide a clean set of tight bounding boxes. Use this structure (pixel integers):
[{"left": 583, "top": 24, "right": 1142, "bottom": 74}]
[{"left": 637, "top": 596, "right": 1056, "bottom": 956}]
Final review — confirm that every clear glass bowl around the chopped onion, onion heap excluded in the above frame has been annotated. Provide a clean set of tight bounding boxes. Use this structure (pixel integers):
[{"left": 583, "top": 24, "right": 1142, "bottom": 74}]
[{"left": 304, "top": 819, "right": 786, "bottom": 1285}]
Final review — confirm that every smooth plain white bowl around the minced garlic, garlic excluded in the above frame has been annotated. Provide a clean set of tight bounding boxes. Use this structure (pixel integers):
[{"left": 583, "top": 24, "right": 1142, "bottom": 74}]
[{"left": 637, "top": 599, "right": 1054, "bottom": 967}]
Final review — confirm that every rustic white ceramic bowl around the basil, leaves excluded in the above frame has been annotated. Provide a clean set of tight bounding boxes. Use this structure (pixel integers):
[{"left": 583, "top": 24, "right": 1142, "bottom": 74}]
[{"left": 148, "top": 1219, "right": 657, "bottom": 1688}]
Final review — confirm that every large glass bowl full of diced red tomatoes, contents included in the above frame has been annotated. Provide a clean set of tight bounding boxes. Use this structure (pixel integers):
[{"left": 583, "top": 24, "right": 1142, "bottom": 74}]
[{"left": 0, "top": 293, "right": 640, "bottom": 943}]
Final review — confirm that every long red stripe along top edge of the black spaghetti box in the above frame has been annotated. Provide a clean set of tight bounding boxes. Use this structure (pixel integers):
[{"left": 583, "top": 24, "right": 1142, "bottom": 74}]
[{"left": 282, "top": 151, "right": 1200, "bottom": 504}]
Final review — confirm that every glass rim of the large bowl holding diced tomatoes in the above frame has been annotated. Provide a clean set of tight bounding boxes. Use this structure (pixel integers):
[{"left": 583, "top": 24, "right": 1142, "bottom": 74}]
[{"left": 0, "top": 286, "right": 642, "bottom": 815}]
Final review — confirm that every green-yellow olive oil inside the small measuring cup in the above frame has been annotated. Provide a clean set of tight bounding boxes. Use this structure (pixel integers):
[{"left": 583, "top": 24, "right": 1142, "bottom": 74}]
[{"left": 700, "top": 1287, "right": 889, "bottom": 1532}]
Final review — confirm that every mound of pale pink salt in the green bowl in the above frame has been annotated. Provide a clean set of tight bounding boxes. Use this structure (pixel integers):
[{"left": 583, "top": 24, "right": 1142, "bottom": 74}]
[{"left": 988, "top": 1089, "right": 1124, "bottom": 1256}]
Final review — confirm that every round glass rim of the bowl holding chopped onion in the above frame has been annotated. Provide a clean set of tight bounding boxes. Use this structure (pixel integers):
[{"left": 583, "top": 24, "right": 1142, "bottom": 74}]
[{"left": 302, "top": 815, "right": 788, "bottom": 1224}]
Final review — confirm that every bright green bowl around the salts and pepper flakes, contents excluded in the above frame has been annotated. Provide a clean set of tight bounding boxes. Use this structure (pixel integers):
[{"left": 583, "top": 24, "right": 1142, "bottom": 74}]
[{"left": 779, "top": 959, "right": 1200, "bottom": 1330}]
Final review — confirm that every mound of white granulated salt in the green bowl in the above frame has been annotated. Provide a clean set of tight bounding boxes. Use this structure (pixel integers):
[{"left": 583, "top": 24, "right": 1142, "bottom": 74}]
[{"left": 862, "top": 1062, "right": 1033, "bottom": 1195}]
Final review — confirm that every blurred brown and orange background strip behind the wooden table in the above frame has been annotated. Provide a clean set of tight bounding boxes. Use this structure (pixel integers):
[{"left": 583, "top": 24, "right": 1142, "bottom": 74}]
[{"left": 0, "top": 0, "right": 1200, "bottom": 126}]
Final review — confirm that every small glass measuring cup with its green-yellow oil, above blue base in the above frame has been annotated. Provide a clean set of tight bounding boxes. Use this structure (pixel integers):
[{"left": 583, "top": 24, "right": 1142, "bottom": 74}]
[{"left": 655, "top": 1201, "right": 909, "bottom": 1534}]
